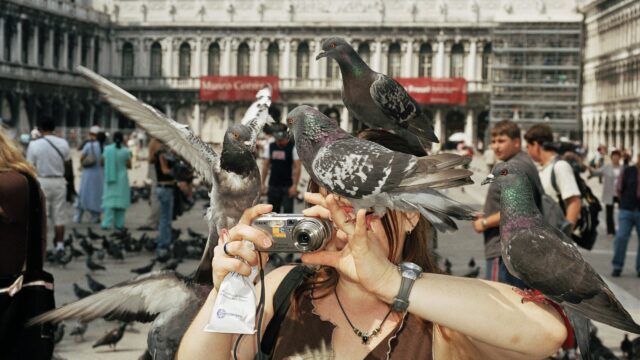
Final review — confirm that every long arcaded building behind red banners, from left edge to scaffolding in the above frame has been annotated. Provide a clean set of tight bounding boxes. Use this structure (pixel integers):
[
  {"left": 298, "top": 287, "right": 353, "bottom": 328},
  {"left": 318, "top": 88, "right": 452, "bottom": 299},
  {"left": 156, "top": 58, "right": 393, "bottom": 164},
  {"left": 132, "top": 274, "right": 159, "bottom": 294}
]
[{"left": 0, "top": 0, "right": 580, "bottom": 149}]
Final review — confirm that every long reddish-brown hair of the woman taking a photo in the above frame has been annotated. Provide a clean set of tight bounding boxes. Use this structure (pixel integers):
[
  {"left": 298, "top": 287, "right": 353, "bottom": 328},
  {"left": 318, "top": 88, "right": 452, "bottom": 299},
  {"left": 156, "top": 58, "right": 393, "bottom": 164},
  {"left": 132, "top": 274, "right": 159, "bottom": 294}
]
[{"left": 292, "top": 130, "right": 442, "bottom": 314}]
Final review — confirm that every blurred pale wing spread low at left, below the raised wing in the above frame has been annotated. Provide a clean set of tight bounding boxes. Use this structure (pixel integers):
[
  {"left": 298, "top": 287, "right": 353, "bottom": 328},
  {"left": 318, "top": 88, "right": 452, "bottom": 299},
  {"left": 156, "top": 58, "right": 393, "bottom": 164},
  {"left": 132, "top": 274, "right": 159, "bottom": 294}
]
[{"left": 28, "top": 271, "right": 197, "bottom": 325}]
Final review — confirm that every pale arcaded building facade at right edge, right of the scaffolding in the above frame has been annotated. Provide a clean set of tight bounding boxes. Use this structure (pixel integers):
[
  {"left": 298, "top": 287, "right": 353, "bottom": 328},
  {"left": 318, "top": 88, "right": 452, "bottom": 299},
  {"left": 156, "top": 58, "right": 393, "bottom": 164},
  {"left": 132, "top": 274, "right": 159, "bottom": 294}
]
[{"left": 581, "top": 0, "right": 640, "bottom": 155}]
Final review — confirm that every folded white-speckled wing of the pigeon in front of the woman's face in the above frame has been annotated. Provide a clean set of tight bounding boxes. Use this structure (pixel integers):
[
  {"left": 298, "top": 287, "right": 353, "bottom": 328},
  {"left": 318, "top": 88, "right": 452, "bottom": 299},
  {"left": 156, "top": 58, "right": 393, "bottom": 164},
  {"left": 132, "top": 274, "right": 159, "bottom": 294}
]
[{"left": 310, "top": 138, "right": 416, "bottom": 199}]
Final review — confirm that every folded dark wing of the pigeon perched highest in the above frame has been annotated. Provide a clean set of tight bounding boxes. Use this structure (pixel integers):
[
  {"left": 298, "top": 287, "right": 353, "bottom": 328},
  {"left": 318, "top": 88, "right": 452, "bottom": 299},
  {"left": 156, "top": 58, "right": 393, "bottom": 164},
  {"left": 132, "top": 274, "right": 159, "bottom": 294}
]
[{"left": 369, "top": 74, "right": 438, "bottom": 143}]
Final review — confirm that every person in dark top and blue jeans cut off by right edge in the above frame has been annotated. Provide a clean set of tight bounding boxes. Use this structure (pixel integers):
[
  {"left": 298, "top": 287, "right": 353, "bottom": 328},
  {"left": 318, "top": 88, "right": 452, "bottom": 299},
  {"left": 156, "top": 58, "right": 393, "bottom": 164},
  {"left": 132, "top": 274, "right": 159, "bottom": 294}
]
[{"left": 611, "top": 155, "right": 640, "bottom": 277}]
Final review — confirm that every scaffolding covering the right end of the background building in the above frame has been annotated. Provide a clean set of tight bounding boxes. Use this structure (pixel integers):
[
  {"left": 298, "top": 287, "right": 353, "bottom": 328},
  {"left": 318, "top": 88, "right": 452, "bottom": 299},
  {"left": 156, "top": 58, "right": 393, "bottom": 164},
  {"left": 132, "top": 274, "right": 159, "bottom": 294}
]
[{"left": 490, "top": 23, "right": 582, "bottom": 138}]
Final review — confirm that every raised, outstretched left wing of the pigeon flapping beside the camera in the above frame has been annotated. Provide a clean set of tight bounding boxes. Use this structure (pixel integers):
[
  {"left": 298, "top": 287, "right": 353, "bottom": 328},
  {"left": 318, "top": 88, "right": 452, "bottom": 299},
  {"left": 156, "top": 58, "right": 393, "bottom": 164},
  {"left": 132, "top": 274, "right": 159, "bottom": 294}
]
[{"left": 77, "top": 66, "right": 220, "bottom": 184}]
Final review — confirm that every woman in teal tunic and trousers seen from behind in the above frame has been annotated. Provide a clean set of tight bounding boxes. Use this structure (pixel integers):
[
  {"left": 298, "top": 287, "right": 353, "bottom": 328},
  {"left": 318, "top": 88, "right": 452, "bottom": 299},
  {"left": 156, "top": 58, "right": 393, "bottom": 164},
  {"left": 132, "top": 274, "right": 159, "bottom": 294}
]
[{"left": 100, "top": 132, "right": 131, "bottom": 229}]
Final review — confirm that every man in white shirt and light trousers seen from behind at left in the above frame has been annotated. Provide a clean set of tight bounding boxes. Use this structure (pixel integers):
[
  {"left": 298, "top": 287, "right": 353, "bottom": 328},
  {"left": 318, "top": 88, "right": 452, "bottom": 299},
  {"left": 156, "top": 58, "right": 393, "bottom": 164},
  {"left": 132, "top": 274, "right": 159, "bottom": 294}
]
[{"left": 27, "top": 117, "right": 69, "bottom": 250}]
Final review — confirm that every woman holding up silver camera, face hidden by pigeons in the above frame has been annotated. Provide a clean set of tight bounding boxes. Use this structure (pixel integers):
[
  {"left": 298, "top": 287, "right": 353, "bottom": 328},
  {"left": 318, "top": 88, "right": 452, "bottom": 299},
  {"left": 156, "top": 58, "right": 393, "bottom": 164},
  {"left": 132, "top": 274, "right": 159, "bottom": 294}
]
[{"left": 177, "top": 189, "right": 567, "bottom": 359}]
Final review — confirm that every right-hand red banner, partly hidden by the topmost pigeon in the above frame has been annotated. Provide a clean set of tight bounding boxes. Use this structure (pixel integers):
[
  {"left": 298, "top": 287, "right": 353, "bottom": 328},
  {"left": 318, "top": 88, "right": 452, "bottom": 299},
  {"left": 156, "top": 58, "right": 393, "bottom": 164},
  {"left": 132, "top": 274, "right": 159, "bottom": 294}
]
[{"left": 395, "top": 78, "right": 467, "bottom": 105}]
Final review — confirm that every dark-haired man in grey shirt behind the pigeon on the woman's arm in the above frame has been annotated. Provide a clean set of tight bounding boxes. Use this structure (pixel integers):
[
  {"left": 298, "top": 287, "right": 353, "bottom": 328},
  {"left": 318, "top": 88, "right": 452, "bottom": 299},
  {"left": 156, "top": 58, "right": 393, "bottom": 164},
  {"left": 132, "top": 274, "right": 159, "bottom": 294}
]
[{"left": 472, "top": 120, "right": 543, "bottom": 288}]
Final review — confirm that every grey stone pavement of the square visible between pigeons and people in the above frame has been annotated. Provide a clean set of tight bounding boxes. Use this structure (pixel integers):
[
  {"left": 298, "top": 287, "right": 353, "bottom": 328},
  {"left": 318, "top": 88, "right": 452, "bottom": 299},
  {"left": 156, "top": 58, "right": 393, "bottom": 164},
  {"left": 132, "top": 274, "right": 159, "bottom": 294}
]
[{"left": 46, "top": 151, "right": 640, "bottom": 360}]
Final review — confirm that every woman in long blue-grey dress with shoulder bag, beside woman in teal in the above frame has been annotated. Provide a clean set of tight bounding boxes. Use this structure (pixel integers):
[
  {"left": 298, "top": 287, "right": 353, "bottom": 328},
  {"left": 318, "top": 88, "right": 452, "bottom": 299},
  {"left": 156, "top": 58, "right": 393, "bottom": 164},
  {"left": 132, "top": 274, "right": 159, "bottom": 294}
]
[{"left": 73, "top": 126, "right": 103, "bottom": 224}]
